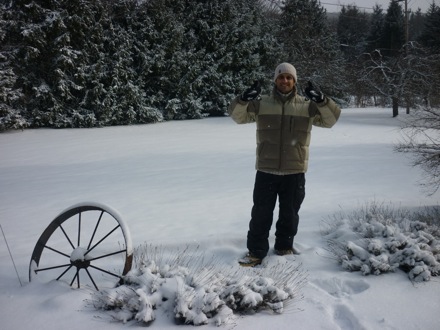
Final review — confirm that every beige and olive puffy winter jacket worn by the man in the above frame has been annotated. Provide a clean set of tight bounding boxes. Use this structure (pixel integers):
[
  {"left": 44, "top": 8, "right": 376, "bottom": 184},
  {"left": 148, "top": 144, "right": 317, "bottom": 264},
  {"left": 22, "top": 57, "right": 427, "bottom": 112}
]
[{"left": 229, "top": 89, "right": 341, "bottom": 175}]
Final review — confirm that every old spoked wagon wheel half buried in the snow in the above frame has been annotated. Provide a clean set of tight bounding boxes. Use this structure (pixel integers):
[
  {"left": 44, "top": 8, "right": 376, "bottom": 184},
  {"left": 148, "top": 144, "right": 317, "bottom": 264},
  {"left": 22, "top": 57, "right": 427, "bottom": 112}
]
[{"left": 29, "top": 203, "right": 133, "bottom": 290}]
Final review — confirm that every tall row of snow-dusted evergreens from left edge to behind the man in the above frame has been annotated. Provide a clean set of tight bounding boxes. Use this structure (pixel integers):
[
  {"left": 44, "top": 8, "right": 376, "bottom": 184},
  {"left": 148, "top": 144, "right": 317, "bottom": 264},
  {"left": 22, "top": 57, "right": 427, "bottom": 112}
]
[{"left": 0, "top": 0, "right": 343, "bottom": 130}]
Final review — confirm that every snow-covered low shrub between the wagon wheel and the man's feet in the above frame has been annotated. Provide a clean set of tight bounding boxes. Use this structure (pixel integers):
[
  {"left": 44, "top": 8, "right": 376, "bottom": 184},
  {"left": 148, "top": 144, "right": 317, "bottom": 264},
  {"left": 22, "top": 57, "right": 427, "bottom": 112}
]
[{"left": 93, "top": 245, "right": 306, "bottom": 325}]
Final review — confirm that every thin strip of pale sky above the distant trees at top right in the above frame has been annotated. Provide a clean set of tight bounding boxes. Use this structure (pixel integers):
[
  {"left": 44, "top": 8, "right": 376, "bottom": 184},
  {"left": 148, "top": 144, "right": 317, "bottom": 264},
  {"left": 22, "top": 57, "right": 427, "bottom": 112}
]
[{"left": 321, "top": 0, "right": 434, "bottom": 13}]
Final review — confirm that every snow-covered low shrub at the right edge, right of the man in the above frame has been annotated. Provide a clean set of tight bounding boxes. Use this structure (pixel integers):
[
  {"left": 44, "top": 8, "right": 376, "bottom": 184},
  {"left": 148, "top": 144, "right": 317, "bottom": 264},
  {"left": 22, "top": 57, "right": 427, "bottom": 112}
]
[{"left": 322, "top": 203, "right": 440, "bottom": 282}]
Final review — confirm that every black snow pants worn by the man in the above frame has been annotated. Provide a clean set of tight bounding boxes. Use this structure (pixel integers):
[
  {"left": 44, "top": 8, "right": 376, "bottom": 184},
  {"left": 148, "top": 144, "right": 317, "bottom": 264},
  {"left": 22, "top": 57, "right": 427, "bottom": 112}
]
[{"left": 247, "top": 171, "right": 305, "bottom": 258}]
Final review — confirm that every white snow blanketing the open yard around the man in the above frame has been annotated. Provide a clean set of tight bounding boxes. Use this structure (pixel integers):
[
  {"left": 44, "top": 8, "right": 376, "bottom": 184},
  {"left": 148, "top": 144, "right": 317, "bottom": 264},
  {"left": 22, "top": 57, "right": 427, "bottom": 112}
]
[{"left": 0, "top": 108, "right": 440, "bottom": 330}]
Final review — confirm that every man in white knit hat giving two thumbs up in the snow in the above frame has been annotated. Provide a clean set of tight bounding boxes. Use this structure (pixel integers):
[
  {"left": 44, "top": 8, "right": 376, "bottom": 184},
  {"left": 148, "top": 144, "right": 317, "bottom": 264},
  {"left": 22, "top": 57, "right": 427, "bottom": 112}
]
[{"left": 229, "top": 63, "right": 341, "bottom": 267}]
